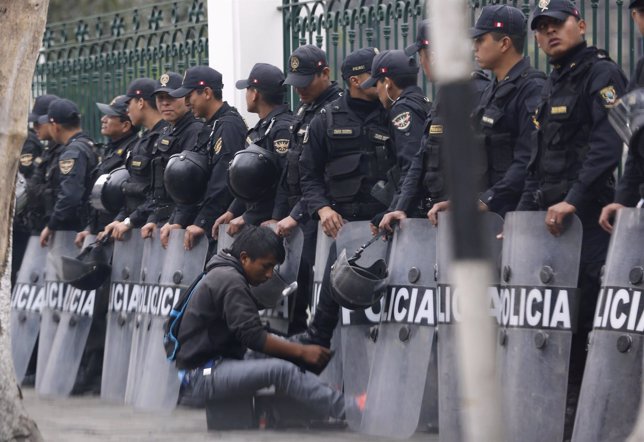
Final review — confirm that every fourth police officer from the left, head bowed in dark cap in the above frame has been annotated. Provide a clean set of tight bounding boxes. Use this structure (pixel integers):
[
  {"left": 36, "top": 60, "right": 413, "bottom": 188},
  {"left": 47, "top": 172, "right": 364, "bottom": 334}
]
[{"left": 99, "top": 78, "right": 168, "bottom": 240}]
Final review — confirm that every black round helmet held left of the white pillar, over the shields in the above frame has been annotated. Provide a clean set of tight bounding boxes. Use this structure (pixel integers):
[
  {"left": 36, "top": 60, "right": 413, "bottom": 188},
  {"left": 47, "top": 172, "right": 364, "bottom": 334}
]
[{"left": 163, "top": 150, "right": 210, "bottom": 204}]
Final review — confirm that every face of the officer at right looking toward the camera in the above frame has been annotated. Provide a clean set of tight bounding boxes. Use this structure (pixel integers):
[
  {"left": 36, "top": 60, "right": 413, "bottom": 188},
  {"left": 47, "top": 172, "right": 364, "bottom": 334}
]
[{"left": 535, "top": 15, "right": 586, "bottom": 60}]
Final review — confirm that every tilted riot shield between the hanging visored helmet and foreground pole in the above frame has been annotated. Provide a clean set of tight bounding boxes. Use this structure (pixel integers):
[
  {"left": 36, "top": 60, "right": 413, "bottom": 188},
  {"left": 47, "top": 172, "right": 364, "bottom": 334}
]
[{"left": 362, "top": 219, "right": 436, "bottom": 439}]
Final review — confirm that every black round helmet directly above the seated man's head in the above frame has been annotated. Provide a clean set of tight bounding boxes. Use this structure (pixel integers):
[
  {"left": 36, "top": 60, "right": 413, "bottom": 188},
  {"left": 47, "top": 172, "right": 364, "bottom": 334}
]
[{"left": 228, "top": 144, "right": 280, "bottom": 203}]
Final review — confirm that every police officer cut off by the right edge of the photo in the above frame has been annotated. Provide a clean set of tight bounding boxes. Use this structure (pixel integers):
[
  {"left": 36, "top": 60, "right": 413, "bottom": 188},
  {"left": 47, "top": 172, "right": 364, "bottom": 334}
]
[{"left": 599, "top": 0, "right": 644, "bottom": 233}]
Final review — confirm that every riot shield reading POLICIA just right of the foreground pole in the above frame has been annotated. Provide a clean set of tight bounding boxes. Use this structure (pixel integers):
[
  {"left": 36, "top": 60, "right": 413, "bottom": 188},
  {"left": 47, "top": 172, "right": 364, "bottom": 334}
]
[{"left": 497, "top": 212, "right": 582, "bottom": 442}]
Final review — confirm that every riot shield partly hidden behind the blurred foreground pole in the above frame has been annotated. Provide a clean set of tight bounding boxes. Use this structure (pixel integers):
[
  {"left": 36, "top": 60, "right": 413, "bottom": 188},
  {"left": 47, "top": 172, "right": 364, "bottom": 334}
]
[{"left": 436, "top": 212, "right": 511, "bottom": 442}]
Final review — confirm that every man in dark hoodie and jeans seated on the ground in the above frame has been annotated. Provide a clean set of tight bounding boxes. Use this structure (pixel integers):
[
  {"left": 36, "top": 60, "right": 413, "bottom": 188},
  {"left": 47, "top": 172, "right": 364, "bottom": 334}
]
[{"left": 176, "top": 226, "right": 364, "bottom": 418}]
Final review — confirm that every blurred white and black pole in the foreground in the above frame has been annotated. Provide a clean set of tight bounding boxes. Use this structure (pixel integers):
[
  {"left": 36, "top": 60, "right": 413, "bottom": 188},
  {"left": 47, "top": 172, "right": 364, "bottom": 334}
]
[{"left": 426, "top": 0, "right": 504, "bottom": 441}]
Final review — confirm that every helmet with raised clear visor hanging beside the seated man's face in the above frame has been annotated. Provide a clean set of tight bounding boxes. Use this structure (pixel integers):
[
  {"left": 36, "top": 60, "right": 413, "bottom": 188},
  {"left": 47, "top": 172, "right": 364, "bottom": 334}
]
[{"left": 331, "top": 249, "right": 389, "bottom": 310}]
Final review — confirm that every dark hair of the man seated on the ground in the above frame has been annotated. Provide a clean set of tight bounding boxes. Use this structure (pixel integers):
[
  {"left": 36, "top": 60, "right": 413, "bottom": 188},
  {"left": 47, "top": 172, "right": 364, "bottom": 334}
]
[{"left": 230, "top": 226, "right": 286, "bottom": 264}]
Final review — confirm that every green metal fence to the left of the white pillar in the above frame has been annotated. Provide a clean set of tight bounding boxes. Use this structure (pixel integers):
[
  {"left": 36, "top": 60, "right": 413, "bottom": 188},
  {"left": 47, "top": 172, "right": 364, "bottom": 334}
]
[{"left": 32, "top": 0, "right": 208, "bottom": 140}]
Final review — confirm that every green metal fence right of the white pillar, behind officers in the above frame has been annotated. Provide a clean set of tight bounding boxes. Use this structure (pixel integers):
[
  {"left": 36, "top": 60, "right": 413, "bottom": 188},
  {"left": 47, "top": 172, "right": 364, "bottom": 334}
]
[{"left": 280, "top": 0, "right": 640, "bottom": 99}]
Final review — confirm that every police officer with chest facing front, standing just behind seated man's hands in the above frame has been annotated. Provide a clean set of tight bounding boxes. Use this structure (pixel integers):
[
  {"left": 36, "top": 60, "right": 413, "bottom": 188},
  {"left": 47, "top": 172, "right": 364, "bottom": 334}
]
[{"left": 300, "top": 48, "right": 397, "bottom": 347}]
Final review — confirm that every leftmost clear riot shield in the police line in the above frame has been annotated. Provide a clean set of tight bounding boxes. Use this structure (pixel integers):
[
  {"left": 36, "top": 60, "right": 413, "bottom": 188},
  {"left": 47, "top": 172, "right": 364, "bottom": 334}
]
[{"left": 11, "top": 236, "right": 47, "bottom": 382}]
